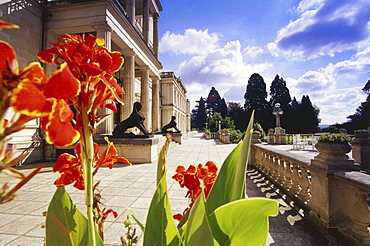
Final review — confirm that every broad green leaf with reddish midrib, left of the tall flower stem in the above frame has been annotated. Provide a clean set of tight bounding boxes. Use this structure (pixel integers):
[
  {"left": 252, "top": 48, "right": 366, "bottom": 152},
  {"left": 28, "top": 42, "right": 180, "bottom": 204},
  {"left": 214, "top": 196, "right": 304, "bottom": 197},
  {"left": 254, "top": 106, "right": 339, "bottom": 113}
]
[{"left": 45, "top": 187, "right": 103, "bottom": 246}]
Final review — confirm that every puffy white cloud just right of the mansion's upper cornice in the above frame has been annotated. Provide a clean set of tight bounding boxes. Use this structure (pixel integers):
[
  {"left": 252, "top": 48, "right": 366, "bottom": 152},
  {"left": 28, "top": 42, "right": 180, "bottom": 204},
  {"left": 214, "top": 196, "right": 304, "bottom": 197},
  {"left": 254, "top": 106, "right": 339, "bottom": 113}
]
[{"left": 159, "top": 29, "right": 219, "bottom": 55}]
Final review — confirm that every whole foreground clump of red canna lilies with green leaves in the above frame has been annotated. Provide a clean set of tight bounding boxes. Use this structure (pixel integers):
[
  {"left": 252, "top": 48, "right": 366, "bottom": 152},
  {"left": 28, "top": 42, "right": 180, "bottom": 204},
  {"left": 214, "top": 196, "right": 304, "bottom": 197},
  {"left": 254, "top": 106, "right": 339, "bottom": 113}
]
[{"left": 0, "top": 19, "right": 278, "bottom": 246}]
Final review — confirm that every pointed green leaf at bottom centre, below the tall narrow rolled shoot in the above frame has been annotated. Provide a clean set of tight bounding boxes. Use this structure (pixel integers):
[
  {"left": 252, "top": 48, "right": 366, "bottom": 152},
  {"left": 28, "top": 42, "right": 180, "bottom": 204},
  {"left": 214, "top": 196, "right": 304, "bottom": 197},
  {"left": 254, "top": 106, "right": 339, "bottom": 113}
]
[{"left": 143, "top": 175, "right": 182, "bottom": 246}]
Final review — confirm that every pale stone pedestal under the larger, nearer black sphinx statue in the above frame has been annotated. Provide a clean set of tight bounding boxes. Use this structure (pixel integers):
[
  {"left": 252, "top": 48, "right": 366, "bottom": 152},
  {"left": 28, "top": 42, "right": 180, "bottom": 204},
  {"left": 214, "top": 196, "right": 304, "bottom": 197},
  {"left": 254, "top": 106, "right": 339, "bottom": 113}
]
[{"left": 94, "top": 136, "right": 159, "bottom": 164}]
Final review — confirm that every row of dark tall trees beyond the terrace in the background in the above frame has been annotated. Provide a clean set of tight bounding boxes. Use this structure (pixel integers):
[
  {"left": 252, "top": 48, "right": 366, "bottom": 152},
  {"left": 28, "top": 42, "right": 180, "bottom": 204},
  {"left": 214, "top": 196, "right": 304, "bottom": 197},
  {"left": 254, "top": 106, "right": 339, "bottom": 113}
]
[{"left": 192, "top": 73, "right": 320, "bottom": 134}]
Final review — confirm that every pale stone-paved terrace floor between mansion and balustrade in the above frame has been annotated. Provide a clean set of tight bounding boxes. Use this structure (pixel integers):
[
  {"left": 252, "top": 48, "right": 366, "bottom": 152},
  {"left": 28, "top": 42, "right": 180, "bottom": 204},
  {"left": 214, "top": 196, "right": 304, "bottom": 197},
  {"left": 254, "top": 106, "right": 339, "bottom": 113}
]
[{"left": 0, "top": 133, "right": 346, "bottom": 246}]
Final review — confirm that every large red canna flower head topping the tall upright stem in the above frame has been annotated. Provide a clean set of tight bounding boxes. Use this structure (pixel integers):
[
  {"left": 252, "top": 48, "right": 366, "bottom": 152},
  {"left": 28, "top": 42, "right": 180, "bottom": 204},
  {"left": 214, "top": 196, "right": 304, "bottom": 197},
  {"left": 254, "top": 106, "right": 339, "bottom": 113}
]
[{"left": 37, "top": 34, "right": 123, "bottom": 119}]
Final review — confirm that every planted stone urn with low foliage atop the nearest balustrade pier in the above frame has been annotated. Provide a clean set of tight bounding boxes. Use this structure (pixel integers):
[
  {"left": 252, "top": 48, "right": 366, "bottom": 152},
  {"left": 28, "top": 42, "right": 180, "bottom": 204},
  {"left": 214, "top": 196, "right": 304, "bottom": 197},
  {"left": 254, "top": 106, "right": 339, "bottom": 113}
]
[{"left": 315, "top": 133, "right": 352, "bottom": 156}]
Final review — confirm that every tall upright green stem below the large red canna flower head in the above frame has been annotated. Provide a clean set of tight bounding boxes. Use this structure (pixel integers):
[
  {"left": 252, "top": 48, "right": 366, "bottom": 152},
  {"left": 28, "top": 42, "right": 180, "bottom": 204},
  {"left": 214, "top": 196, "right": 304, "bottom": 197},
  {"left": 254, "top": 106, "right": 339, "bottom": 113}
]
[{"left": 80, "top": 100, "right": 96, "bottom": 246}]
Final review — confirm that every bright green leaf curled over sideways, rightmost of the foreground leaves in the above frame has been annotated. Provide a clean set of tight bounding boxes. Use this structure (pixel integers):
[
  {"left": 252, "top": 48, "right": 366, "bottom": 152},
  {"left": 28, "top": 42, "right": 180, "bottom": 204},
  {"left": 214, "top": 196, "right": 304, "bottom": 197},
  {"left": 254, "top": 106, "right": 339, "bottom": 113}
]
[{"left": 209, "top": 198, "right": 278, "bottom": 246}]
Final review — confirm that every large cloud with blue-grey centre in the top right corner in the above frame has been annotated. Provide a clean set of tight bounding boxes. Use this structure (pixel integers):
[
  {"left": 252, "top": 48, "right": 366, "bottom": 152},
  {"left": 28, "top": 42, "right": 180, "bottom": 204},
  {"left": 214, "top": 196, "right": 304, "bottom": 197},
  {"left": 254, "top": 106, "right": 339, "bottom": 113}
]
[{"left": 267, "top": 0, "right": 369, "bottom": 61}]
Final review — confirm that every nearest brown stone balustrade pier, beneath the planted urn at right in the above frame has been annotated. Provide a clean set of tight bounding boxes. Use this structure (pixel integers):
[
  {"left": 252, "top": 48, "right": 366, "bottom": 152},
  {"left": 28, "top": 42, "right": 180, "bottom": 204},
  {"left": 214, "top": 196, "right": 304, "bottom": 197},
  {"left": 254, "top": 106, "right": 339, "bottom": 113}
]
[{"left": 308, "top": 142, "right": 359, "bottom": 232}]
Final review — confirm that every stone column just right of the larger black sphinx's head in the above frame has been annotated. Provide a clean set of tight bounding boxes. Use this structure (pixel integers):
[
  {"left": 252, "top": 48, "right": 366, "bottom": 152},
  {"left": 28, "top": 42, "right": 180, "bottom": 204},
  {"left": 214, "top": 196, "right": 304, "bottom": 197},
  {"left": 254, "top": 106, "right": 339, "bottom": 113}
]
[{"left": 140, "top": 66, "right": 151, "bottom": 131}]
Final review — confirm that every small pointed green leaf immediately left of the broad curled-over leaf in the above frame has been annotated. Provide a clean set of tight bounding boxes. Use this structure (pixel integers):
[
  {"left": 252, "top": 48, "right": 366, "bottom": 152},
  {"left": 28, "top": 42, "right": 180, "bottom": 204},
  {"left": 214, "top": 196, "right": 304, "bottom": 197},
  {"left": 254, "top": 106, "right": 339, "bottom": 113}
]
[{"left": 185, "top": 191, "right": 213, "bottom": 246}]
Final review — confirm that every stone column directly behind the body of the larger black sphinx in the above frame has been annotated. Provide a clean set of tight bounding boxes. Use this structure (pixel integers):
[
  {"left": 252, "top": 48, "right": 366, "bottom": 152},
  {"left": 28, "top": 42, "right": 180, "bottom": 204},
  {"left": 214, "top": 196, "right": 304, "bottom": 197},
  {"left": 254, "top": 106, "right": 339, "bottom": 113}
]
[{"left": 121, "top": 51, "right": 135, "bottom": 120}]
